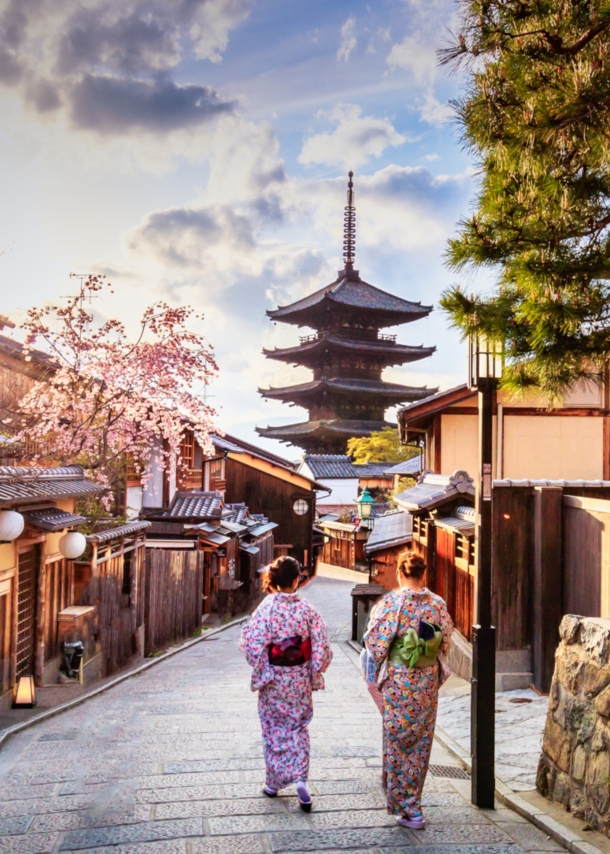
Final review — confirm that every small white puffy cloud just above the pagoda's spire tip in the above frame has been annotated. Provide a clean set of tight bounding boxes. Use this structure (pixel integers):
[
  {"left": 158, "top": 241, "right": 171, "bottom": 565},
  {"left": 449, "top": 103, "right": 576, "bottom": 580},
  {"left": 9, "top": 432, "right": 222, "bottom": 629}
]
[{"left": 298, "top": 104, "right": 407, "bottom": 168}]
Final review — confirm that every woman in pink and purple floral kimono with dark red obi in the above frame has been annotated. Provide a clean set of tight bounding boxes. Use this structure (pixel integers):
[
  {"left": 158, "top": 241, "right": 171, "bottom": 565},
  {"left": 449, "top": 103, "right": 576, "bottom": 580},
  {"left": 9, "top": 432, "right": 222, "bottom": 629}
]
[{"left": 241, "top": 557, "right": 332, "bottom": 812}]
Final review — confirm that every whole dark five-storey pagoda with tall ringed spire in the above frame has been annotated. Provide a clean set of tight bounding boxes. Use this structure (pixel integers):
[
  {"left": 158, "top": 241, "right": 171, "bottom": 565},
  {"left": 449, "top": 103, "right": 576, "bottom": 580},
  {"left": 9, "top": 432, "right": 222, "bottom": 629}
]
[{"left": 256, "top": 172, "right": 437, "bottom": 454}]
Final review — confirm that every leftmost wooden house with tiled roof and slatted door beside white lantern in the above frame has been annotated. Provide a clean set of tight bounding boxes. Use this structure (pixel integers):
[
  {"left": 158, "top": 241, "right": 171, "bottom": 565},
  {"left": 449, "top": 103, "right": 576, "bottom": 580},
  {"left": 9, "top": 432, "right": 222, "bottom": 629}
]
[{"left": 0, "top": 466, "right": 105, "bottom": 702}]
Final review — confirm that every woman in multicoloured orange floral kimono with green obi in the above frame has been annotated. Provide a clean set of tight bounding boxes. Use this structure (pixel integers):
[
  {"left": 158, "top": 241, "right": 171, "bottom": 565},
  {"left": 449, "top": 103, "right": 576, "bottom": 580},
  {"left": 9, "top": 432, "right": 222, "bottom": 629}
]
[{"left": 364, "top": 551, "right": 453, "bottom": 830}]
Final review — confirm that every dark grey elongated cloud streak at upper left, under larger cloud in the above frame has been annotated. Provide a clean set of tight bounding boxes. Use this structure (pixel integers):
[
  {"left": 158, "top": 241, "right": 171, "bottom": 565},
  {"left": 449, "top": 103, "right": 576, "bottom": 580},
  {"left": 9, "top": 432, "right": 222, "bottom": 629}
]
[{"left": 71, "top": 75, "right": 233, "bottom": 134}]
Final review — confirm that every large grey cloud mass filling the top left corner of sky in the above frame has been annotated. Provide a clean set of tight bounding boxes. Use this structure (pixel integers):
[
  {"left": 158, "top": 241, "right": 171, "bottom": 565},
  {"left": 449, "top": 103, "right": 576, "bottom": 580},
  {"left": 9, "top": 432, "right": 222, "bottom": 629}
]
[{"left": 0, "top": 0, "right": 251, "bottom": 137}]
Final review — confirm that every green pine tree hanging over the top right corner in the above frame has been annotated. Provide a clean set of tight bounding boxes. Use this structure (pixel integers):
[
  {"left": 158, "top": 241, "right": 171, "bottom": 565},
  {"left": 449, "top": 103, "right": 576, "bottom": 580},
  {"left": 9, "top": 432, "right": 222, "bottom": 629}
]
[{"left": 441, "top": 0, "right": 610, "bottom": 399}]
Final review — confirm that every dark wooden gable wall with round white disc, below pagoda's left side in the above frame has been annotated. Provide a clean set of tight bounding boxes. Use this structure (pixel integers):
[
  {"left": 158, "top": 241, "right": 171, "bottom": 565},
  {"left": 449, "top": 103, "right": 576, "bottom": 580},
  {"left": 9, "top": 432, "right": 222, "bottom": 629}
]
[{"left": 225, "top": 459, "right": 315, "bottom": 569}]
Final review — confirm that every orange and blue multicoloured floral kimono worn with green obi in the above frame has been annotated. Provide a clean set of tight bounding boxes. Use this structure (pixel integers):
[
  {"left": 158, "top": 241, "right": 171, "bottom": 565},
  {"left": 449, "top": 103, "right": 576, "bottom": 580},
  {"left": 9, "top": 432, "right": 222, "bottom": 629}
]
[{"left": 364, "top": 587, "right": 453, "bottom": 816}]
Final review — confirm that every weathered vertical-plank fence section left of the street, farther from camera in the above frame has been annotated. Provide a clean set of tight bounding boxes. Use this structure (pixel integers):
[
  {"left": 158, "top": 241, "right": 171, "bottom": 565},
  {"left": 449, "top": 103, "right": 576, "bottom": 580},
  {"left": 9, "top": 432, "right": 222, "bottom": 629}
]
[{"left": 144, "top": 548, "right": 204, "bottom": 655}]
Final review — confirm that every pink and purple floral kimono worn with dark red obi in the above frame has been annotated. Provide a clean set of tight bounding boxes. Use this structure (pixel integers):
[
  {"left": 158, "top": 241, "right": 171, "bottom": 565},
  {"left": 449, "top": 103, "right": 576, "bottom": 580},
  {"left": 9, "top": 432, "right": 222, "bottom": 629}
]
[{"left": 241, "top": 593, "right": 332, "bottom": 791}]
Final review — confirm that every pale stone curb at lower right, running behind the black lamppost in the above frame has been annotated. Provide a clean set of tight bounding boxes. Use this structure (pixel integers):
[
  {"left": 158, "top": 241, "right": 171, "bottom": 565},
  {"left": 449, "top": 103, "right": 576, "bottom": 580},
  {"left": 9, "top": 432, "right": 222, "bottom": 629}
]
[{"left": 434, "top": 727, "right": 604, "bottom": 854}]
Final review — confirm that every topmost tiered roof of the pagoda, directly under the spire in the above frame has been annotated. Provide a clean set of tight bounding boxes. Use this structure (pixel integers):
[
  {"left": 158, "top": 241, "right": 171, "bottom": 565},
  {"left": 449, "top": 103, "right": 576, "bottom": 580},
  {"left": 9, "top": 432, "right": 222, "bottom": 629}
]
[{"left": 267, "top": 267, "right": 432, "bottom": 329}]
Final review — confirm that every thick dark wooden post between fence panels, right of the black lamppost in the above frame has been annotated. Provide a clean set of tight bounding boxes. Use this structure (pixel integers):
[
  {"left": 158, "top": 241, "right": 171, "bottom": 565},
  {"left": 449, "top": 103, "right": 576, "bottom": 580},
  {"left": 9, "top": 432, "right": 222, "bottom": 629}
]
[{"left": 532, "top": 486, "right": 563, "bottom": 694}]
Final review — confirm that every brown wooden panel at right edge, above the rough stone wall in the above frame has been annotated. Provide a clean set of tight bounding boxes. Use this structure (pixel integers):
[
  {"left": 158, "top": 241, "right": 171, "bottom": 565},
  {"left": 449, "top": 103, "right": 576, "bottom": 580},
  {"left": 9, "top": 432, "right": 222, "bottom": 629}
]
[{"left": 563, "top": 495, "right": 610, "bottom": 617}]
